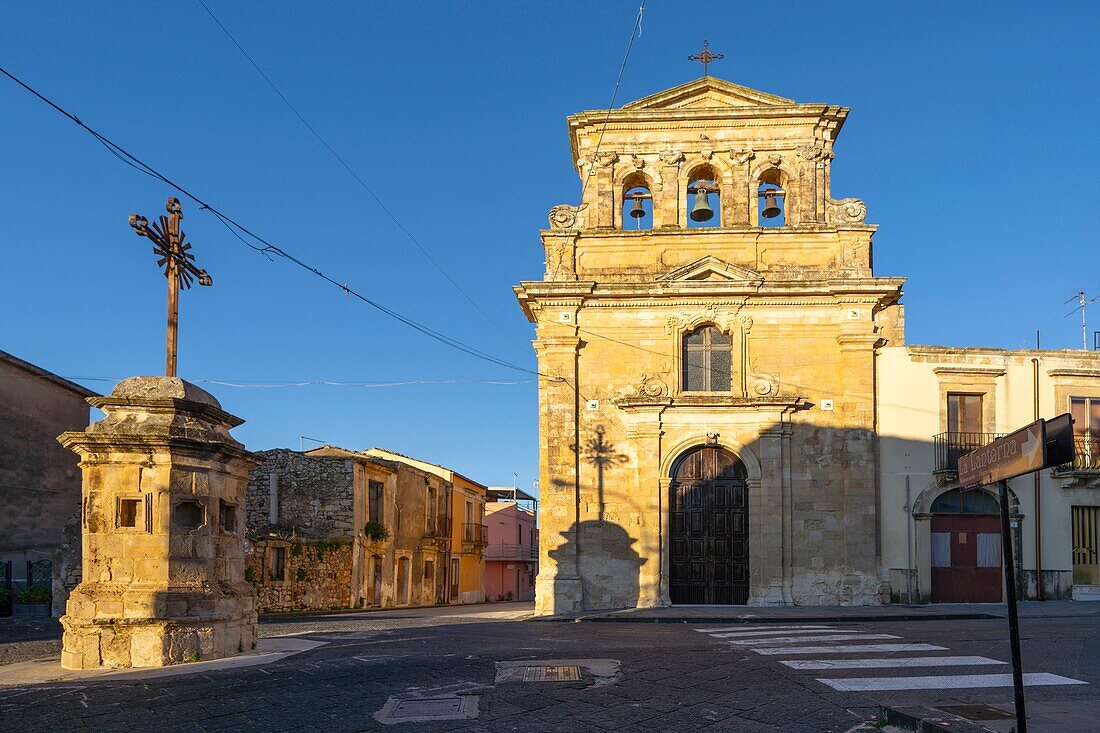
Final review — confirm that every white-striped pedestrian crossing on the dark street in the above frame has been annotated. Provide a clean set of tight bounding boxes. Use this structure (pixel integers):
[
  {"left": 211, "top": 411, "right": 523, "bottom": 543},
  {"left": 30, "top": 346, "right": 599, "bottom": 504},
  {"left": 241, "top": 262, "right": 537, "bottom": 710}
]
[{"left": 696, "top": 624, "right": 1088, "bottom": 692}]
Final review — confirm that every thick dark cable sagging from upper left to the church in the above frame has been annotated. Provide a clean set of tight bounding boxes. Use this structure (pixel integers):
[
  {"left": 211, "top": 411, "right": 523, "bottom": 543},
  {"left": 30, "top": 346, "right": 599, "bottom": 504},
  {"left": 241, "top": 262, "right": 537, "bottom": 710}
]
[{"left": 0, "top": 66, "right": 539, "bottom": 375}]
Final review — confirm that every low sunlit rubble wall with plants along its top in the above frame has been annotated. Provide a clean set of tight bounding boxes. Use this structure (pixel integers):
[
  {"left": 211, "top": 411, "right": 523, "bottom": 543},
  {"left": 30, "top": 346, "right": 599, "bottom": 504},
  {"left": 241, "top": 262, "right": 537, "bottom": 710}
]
[{"left": 245, "top": 539, "right": 353, "bottom": 613}]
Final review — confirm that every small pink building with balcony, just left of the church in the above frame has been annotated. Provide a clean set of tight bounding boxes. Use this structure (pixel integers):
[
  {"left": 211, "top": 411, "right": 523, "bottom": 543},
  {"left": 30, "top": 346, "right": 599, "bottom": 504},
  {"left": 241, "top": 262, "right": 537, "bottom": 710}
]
[{"left": 485, "top": 486, "right": 539, "bottom": 601}]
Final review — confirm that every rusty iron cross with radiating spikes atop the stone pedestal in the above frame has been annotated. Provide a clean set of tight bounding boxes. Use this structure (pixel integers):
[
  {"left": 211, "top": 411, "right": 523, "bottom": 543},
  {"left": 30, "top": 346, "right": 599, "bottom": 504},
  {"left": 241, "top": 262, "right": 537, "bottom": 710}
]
[{"left": 130, "top": 196, "right": 213, "bottom": 376}]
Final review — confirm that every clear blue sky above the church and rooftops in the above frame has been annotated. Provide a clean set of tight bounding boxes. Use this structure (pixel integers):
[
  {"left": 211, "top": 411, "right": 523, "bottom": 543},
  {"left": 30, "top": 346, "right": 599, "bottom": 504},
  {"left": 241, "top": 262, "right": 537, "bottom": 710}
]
[{"left": 0, "top": 0, "right": 1100, "bottom": 488}]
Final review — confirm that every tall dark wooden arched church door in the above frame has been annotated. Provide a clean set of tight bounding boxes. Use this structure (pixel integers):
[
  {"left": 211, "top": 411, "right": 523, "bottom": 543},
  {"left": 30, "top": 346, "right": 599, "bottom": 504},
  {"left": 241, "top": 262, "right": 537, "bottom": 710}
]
[{"left": 669, "top": 446, "right": 749, "bottom": 604}]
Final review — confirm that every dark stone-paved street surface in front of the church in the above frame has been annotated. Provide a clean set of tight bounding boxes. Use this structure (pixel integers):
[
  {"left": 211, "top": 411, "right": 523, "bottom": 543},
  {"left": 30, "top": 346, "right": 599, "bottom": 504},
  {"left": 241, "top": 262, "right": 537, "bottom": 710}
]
[{"left": 0, "top": 608, "right": 1100, "bottom": 733}]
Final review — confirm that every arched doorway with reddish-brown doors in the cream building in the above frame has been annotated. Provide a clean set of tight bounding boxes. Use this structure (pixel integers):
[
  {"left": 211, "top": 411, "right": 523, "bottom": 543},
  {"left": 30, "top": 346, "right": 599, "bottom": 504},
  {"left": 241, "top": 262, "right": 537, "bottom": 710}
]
[{"left": 931, "top": 489, "right": 1002, "bottom": 603}]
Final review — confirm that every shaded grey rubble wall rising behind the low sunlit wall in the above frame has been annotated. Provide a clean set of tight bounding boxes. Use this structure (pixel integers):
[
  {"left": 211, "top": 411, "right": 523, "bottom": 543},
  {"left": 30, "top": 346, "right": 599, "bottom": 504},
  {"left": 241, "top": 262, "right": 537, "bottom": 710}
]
[{"left": 248, "top": 448, "right": 362, "bottom": 539}]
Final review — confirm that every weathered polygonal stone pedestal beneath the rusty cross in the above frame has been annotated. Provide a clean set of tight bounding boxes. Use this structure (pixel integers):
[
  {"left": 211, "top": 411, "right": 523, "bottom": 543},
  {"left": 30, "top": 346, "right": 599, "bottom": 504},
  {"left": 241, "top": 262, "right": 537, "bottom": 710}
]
[{"left": 58, "top": 376, "right": 260, "bottom": 669}]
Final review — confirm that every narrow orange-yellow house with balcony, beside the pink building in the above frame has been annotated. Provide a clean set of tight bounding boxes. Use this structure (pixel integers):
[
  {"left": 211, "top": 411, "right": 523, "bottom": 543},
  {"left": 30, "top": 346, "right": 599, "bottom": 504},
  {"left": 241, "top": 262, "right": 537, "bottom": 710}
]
[{"left": 363, "top": 448, "right": 487, "bottom": 603}]
